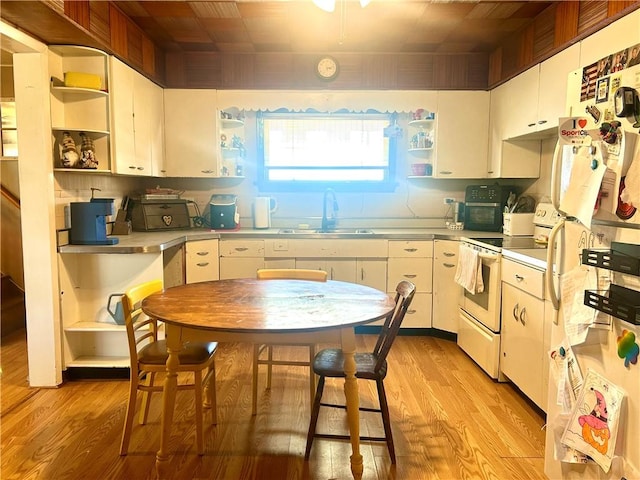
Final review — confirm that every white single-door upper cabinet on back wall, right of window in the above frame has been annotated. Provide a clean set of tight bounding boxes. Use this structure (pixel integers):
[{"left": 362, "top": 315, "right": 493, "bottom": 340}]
[{"left": 433, "top": 91, "right": 490, "bottom": 178}]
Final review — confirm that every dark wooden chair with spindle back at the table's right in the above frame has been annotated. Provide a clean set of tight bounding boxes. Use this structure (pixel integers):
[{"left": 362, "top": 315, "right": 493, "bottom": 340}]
[{"left": 304, "top": 281, "right": 416, "bottom": 463}]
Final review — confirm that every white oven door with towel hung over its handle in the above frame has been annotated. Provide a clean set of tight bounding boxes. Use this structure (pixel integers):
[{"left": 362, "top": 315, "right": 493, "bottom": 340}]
[{"left": 462, "top": 249, "right": 501, "bottom": 332}]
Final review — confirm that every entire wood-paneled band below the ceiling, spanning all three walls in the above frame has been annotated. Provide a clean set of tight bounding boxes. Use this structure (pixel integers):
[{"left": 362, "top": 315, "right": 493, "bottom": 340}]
[{"left": 0, "top": 0, "right": 640, "bottom": 90}]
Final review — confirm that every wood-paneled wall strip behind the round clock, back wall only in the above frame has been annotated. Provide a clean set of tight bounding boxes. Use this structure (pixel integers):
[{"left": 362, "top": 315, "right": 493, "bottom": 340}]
[{"left": 165, "top": 52, "right": 488, "bottom": 90}]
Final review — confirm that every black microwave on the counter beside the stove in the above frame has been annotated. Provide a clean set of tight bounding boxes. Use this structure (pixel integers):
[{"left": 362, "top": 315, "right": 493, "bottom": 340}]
[{"left": 464, "top": 185, "right": 518, "bottom": 232}]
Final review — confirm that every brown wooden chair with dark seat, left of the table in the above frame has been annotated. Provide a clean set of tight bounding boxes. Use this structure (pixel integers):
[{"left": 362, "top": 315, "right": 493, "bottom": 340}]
[{"left": 120, "top": 280, "right": 218, "bottom": 455}]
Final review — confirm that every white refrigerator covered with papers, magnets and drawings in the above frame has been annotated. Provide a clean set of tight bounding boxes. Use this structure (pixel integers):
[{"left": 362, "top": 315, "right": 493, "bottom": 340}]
[{"left": 544, "top": 63, "right": 640, "bottom": 480}]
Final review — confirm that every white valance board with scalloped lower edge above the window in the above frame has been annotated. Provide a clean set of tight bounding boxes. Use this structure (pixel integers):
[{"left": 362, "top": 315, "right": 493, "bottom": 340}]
[{"left": 217, "top": 90, "right": 438, "bottom": 113}]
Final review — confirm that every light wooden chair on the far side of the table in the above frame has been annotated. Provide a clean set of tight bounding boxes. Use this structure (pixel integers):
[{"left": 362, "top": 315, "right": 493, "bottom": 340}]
[{"left": 251, "top": 268, "right": 327, "bottom": 415}]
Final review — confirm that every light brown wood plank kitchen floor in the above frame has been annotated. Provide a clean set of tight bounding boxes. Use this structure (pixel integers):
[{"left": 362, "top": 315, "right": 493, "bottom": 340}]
[{"left": 0, "top": 332, "right": 545, "bottom": 480}]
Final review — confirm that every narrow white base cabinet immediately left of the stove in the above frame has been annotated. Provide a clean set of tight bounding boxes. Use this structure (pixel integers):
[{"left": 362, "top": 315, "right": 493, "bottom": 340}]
[{"left": 432, "top": 240, "right": 462, "bottom": 333}]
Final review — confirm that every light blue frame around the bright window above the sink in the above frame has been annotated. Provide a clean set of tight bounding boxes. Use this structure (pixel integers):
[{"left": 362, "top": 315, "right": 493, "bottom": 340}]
[{"left": 256, "top": 109, "right": 398, "bottom": 192}]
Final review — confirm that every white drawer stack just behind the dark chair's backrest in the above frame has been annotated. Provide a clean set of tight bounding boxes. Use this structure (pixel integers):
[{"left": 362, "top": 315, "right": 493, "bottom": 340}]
[{"left": 388, "top": 240, "right": 433, "bottom": 328}]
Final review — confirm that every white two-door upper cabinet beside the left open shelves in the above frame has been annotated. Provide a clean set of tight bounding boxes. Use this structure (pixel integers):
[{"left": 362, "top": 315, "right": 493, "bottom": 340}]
[{"left": 111, "top": 57, "right": 164, "bottom": 176}]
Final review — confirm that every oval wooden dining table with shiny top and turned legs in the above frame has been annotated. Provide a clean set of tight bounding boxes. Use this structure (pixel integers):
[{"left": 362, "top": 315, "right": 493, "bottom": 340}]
[{"left": 142, "top": 279, "right": 395, "bottom": 479}]
